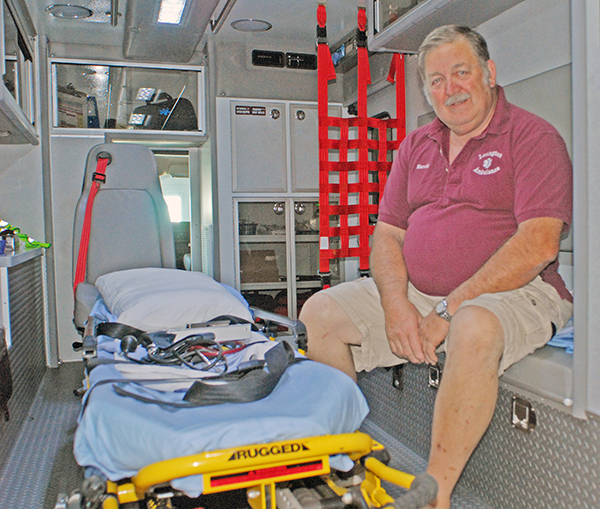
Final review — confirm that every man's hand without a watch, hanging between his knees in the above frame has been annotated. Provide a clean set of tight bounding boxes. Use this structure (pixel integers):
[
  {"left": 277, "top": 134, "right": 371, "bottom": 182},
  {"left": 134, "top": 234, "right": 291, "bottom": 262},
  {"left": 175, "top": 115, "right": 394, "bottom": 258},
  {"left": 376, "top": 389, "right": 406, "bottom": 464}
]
[{"left": 385, "top": 300, "right": 425, "bottom": 364}]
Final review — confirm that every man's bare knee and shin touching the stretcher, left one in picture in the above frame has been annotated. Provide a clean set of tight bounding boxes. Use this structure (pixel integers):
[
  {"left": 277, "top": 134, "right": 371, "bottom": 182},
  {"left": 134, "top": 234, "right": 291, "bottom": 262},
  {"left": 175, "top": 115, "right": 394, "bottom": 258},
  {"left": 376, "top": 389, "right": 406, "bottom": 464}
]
[{"left": 299, "top": 292, "right": 362, "bottom": 381}]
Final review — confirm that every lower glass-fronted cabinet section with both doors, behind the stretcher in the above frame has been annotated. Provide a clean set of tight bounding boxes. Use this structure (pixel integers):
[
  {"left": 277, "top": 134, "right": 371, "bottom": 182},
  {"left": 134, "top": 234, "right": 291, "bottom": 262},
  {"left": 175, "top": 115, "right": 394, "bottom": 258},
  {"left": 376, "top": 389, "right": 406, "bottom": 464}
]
[{"left": 235, "top": 198, "right": 340, "bottom": 318}]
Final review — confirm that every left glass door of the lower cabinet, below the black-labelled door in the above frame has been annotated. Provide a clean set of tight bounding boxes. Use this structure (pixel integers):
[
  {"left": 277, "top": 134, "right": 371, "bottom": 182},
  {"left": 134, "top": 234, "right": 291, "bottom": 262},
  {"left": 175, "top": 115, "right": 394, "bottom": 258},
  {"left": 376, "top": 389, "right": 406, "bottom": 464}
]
[{"left": 237, "top": 200, "right": 288, "bottom": 316}]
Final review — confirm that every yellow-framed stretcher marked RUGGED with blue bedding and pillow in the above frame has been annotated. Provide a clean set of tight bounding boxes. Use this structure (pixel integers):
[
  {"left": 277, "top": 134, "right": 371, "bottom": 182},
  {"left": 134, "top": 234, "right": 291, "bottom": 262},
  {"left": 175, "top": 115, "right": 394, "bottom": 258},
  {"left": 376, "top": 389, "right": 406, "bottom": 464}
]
[{"left": 56, "top": 269, "right": 437, "bottom": 509}]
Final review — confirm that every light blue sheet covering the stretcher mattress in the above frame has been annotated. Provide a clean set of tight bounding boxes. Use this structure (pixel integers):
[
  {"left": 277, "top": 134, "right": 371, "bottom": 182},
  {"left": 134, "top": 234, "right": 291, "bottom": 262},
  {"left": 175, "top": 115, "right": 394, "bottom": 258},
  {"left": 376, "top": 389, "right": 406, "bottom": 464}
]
[{"left": 74, "top": 306, "right": 368, "bottom": 497}]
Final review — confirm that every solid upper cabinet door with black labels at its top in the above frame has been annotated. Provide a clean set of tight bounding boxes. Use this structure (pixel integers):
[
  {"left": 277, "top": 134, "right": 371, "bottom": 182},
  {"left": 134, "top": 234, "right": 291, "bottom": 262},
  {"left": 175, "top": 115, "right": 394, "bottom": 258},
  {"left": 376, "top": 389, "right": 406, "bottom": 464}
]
[{"left": 230, "top": 101, "right": 287, "bottom": 193}]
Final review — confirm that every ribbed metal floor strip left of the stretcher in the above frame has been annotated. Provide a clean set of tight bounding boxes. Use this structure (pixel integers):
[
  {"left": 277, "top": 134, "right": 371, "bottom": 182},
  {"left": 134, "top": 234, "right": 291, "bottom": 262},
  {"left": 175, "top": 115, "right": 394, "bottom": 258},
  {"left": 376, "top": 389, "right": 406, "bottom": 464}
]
[{"left": 0, "top": 363, "right": 83, "bottom": 509}]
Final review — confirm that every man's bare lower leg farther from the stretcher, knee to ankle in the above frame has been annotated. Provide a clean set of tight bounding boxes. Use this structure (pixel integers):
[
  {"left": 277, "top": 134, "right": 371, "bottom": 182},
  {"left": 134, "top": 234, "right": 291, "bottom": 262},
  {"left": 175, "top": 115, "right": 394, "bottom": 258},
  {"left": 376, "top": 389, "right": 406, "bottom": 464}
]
[{"left": 427, "top": 306, "right": 504, "bottom": 509}]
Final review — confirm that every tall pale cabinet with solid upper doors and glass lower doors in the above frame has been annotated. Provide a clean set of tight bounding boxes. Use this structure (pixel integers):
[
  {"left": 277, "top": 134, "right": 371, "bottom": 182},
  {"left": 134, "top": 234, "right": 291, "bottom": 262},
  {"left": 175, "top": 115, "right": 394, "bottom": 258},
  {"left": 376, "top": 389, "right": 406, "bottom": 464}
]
[{"left": 217, "top": 98, "right": 342, "bottom": 318}]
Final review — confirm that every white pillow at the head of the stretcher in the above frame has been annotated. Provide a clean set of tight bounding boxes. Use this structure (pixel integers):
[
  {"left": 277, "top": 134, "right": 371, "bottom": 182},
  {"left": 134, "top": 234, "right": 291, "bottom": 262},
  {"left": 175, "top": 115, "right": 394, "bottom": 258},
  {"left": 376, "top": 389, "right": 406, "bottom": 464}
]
[{"left": 96, "top": 268, "right": 252, "bottom": 332}]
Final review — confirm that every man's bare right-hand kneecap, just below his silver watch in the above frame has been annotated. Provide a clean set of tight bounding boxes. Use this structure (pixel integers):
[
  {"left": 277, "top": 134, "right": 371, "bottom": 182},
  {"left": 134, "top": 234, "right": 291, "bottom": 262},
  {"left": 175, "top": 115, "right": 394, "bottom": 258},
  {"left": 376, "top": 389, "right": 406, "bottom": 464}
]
[{"left": 446, "top": 305, "right": 504, "bottom": 363}]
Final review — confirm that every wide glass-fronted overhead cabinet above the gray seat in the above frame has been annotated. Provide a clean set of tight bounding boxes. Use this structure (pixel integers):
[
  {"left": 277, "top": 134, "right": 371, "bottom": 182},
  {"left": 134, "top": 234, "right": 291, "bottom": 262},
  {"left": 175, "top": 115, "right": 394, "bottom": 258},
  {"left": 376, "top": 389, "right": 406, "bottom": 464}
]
[{"left": 52, "top": 62, "right": 204, "bottom": 132}]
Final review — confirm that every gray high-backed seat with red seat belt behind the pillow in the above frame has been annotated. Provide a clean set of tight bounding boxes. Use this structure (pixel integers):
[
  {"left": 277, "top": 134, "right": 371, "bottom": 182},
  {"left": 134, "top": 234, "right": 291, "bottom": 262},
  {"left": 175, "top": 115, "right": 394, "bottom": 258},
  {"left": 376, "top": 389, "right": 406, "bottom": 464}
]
[{"left": 73, "top": 143, "right": 175, "bottom": 330}]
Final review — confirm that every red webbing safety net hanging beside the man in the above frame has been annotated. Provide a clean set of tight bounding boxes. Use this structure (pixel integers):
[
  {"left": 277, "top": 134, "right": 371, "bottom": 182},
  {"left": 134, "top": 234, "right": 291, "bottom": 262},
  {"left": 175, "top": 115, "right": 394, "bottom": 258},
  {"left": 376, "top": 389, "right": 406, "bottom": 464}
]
[{"left": 317, "top": 6, "right": 405, "bottom": 287}]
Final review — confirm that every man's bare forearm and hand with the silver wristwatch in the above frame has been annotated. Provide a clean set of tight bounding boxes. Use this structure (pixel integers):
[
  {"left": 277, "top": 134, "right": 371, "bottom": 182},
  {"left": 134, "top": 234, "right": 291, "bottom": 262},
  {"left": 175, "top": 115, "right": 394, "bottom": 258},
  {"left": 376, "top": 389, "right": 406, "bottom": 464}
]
[{"left": 420, "top": 217, "right": 563, "bottom": 364}]
